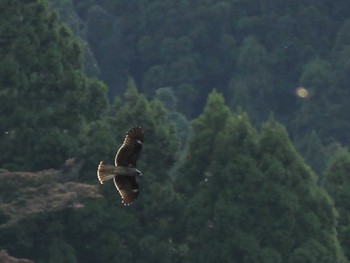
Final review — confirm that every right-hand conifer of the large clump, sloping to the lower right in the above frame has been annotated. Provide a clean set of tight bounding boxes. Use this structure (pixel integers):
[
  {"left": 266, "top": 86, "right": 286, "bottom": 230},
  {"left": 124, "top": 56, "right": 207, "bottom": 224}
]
[{"left": 257, "top": 119, "right": 347, "bottom": 262}]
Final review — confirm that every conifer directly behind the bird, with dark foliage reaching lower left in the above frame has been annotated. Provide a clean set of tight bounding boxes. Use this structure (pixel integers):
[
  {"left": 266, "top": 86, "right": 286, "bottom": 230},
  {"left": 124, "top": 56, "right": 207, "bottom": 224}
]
[{"left": 1, "top": 80, "right": 186, "bottom": 263}]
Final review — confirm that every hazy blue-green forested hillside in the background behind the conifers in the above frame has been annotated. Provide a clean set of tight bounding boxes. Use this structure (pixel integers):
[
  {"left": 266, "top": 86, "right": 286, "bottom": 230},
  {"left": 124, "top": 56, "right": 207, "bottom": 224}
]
[{"left": 47, "top": 0, "right": 350, "bottom": 172}]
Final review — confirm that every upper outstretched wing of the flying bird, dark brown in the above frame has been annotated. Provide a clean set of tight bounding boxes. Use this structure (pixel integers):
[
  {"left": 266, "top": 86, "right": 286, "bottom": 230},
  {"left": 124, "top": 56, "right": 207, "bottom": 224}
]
[{"left": 115, "top": 127, "right": 144, "bottom": 167}]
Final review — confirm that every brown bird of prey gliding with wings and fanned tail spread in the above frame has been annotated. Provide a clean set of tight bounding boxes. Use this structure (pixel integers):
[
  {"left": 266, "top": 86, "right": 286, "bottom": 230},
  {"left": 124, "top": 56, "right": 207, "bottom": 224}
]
[{"left": 97, "top": 127, "right": 144, "bottom": 205}]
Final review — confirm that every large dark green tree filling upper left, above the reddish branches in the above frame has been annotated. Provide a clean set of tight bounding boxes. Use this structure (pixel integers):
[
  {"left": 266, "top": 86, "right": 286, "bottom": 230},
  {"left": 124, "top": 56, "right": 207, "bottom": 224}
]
[{"left": 0, "top": 1, "right": 106, "bottom": 170}]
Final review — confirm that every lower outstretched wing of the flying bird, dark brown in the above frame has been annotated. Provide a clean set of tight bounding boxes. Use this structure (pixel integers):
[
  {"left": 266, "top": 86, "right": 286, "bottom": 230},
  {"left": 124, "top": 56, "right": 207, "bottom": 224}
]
[{"left": 113, "top": 176, "right": 139, "bottom": 205}]
